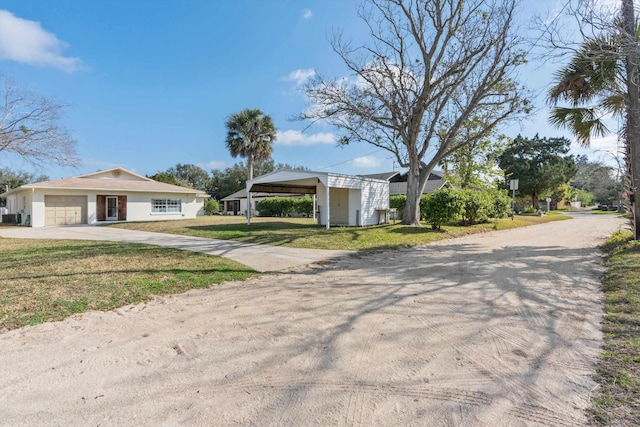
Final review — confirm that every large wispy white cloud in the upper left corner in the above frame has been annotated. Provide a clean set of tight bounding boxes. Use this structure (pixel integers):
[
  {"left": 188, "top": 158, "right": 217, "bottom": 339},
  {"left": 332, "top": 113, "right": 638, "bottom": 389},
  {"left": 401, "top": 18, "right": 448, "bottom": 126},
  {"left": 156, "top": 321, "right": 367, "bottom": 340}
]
[{"left": 0, "top": 10, "right": 82, "bottom": 73}]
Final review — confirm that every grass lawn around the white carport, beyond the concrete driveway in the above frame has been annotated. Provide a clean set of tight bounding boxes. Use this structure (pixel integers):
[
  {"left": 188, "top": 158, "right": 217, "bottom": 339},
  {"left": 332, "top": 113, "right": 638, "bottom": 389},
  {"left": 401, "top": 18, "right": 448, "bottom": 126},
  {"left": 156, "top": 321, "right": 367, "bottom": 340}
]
[{"left": 110, "top": 215, "right": 568, "bottom": 251}]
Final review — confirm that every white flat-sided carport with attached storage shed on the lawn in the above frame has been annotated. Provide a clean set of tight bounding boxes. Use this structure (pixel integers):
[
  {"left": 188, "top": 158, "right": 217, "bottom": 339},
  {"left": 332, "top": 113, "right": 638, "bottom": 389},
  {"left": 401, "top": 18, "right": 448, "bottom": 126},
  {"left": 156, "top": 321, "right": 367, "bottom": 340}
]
[{"left": 246, "top": 170, "right": 389, "bottom": 229}]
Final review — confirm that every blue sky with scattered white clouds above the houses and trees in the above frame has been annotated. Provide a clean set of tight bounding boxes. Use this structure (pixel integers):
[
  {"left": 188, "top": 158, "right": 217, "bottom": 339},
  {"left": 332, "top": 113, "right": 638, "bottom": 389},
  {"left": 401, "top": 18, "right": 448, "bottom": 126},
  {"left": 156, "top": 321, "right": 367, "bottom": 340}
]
[{"left": 0, "top": 0, "right": 615, "bottom": 179}]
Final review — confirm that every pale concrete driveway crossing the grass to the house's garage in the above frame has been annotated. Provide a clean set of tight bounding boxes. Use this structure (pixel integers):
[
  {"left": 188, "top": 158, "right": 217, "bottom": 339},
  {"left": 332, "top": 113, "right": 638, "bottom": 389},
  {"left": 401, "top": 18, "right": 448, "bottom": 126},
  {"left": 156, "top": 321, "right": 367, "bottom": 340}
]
[{"left": 0, "top": 225, "right": 353, "bottom": 272}]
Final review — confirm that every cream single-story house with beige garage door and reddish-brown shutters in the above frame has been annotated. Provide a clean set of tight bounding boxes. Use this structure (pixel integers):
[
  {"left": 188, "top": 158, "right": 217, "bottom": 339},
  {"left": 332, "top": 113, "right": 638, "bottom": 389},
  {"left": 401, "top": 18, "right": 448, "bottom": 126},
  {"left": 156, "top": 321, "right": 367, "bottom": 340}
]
[{"left": 0, "top": 168, "right": 209, "bottom": 227}]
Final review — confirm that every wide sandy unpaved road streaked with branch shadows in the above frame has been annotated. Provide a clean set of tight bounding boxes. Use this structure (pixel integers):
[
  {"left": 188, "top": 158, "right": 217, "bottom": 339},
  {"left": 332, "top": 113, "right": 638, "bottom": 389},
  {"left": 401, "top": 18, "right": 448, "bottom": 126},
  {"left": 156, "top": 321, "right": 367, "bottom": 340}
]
[{"left": 0, "top": 215, "right": 622, "bottom": 426}]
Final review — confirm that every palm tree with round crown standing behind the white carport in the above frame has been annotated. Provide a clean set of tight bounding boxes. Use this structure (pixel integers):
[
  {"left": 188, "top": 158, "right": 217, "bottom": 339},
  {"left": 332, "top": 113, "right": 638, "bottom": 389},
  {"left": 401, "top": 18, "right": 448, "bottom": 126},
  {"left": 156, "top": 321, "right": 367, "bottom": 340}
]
[{"left": 225, "top": 108, "right": 276, "bottom": 180}]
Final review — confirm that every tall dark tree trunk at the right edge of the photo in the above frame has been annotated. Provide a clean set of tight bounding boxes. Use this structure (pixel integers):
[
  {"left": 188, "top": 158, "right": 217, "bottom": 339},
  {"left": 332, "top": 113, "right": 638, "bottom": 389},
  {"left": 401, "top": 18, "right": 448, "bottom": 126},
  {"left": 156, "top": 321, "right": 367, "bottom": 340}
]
[{"left": 622, "top": 0, "right": 640, "bottom": 240}]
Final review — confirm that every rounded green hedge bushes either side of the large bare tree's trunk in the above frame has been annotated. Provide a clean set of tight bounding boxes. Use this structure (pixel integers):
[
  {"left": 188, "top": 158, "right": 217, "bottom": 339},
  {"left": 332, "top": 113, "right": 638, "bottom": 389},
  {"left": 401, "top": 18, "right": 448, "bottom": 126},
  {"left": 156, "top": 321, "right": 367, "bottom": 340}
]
[{"left": 389, "top": 188, "right": 511, "bottom": 228}]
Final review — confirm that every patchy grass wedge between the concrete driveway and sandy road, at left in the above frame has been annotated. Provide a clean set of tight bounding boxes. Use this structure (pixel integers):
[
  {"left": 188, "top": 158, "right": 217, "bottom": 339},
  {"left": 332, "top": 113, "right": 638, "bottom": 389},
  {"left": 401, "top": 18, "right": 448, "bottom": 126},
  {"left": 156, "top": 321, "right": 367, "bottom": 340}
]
[{"left": 0, "top": 238, "right": 255, "bottom": 332}]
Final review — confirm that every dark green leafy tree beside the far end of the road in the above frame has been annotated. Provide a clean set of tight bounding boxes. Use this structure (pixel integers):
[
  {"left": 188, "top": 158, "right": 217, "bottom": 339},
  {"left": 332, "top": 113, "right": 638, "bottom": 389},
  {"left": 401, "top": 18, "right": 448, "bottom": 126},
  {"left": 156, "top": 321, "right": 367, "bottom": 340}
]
[{"left": 498, "top": 135, "right": 577, "bottom": 208}]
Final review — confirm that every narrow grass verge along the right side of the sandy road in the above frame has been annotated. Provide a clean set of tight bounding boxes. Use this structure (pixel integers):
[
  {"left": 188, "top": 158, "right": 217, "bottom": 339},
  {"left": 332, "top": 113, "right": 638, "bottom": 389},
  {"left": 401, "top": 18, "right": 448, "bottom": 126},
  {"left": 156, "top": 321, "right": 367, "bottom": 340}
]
[{"left": 591, "top": 232, "right": 640, "bottom": 425}]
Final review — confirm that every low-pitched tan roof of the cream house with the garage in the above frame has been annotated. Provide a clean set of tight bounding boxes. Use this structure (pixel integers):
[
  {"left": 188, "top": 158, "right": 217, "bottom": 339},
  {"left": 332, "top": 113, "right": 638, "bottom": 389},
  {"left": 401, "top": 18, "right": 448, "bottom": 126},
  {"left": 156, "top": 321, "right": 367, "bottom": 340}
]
[{"left": 2, "top": 168, "right": 209, "bottom": 197}]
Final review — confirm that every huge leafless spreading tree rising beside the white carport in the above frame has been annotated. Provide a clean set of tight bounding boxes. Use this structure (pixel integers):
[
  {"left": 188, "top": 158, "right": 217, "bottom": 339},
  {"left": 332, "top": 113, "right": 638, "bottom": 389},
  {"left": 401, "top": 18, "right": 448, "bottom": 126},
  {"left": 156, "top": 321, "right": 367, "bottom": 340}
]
[{"left": 301, "top": 0, "right": 528, "bottom": 225}]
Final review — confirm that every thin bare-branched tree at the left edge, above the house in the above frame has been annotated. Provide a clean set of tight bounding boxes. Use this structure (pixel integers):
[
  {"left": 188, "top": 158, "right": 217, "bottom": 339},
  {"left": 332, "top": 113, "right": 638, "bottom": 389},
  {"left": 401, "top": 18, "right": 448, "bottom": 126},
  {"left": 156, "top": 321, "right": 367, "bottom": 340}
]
[{"left": 0, "top": 74, "right": 79, "bottom": 166}]
